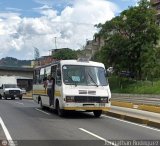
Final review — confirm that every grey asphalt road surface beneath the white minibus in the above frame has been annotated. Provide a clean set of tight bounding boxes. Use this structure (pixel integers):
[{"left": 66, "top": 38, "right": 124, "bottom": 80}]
[{"left": 0, "top": 100, "right": 160, "bottom": 146}]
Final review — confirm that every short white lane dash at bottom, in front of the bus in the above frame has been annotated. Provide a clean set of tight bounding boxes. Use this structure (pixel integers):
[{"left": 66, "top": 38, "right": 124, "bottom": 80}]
[{"left": 79, "top": 128, "right": 118, "bottom": 146}]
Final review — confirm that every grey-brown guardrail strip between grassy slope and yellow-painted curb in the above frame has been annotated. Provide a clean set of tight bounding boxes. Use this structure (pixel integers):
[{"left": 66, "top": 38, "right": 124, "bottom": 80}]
[{"left": 111, "top": 93, "right": 160, "bottom": 106}]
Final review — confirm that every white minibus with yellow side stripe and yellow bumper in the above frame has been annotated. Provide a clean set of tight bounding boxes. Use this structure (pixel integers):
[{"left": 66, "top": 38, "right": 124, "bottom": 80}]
[{"left": 32, "top": 59, "right": 111, "bottom": 117}]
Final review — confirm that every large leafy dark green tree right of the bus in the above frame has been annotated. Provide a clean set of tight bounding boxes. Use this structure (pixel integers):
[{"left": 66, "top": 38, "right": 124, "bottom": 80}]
[{"left": 97, "top": 0, "right": 160, "bottom": 79}]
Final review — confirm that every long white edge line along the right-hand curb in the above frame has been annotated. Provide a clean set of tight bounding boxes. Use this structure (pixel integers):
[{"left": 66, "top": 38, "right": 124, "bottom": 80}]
[{"left": 102, "top": 115, "right": 160, "bottom": 132}]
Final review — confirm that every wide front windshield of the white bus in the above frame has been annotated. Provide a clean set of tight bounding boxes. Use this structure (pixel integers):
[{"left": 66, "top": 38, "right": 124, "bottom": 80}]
[{"left": 62, "top": 65, "right": 108, "bottom": 87}]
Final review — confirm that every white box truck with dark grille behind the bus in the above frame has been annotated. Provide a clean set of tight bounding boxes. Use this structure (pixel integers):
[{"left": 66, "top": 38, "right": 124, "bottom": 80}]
[{"left": 0, "top": 76, "right": 23, "bottom": 100}]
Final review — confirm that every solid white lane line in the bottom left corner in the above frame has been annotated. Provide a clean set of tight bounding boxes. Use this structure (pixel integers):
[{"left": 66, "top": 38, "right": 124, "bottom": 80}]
[{"left": 0, "top": 117, "right": 15, "bottom": 146}]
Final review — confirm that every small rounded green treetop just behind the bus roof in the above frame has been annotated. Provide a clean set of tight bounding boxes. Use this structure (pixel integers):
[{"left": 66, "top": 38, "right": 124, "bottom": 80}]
[{"left": 53, "top": 48, "right": 77, "bottom": 60}]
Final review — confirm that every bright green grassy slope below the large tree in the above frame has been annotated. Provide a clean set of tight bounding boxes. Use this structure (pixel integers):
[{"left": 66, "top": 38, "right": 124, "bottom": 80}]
[{"left": 109, "top": 76, "right": 160, "bottom": 94}]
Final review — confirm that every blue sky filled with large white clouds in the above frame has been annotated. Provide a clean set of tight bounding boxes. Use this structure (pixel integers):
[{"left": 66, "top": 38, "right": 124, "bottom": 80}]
[{"left": 0, "top": 0, "right": 137, "bottom": 59}]
